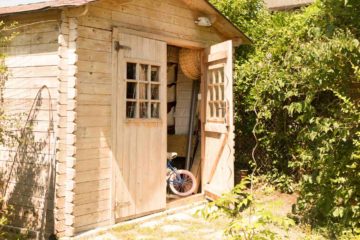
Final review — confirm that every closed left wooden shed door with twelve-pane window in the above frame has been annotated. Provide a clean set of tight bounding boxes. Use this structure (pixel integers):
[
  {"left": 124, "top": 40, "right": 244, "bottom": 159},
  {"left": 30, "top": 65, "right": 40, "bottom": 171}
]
[{"left": 113, "top": 32, "right": 167, "bottom": 220}]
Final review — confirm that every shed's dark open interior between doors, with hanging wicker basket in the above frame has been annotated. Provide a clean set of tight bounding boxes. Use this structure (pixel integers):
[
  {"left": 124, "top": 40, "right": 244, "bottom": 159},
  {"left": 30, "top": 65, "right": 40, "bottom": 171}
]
[{"left": 167, "top": 45, "right": 201, "bottom": 206}]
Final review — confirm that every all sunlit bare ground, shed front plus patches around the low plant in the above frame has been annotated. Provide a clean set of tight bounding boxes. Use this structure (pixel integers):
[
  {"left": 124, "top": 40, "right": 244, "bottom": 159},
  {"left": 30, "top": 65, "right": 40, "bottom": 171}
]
[{"left": 77, "top": 189, "right": 324, "bottom": 240}]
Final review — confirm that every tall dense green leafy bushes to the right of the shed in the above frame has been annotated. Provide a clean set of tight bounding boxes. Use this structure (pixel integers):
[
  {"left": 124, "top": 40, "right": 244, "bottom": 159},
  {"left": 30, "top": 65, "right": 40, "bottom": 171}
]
[{"left": 213, "top": 0, "right": 360, "bottom": 237}]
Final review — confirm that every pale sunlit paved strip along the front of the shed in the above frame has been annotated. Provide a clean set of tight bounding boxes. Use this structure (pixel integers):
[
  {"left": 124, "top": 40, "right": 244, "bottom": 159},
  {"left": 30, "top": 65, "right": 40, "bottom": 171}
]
[{"left": 80, "top": 204, "right": 228, "bottom": 240}]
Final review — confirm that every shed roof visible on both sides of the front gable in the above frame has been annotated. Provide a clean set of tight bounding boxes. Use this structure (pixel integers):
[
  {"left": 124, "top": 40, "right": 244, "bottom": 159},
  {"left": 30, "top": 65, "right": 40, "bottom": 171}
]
[{"left": 0, "top": 0, "right": 251, "bottom": 44}]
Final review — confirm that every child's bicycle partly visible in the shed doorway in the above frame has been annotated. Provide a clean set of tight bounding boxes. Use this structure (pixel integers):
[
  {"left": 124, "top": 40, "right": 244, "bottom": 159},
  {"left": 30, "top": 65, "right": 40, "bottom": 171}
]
[{"left": 166, "top": 153, "right": 196, "bottom": 197}]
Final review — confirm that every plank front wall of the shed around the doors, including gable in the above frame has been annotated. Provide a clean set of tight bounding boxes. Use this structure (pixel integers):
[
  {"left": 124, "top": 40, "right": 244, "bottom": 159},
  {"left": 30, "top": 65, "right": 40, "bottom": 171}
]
[{"left": 74, "top": 0, "right": 225, "bottom": 232}]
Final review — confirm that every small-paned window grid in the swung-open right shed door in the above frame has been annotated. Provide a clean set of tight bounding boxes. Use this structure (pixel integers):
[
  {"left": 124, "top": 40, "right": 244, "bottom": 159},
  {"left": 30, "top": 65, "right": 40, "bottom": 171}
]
[{"left": 207, "top": 65, "right": 226, "bottom": 123}]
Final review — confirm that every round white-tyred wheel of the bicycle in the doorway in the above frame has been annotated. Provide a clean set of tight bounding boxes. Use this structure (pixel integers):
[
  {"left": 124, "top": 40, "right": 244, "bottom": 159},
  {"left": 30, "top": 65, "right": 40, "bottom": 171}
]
[{"left": 169, "top": 169, "right": 196, "bottom": 197}]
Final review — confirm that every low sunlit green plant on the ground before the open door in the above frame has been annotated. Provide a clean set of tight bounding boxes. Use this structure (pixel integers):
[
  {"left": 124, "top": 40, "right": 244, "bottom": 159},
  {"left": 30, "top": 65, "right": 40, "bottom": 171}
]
[{"left": 200, "top": 178, "right": 295, "bottom": 240}]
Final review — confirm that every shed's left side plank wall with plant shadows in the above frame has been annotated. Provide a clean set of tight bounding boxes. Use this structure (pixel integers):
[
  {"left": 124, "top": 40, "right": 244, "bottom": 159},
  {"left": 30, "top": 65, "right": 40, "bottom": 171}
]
[{"left": 0, "top": 11, "right": 59, "bottom": 236}]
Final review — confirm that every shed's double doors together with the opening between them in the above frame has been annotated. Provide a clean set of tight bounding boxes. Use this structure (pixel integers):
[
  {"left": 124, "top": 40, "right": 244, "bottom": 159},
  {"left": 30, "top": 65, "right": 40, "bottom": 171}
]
[{"left": 112, "top": 31, "right": 234, "bottom": 222}]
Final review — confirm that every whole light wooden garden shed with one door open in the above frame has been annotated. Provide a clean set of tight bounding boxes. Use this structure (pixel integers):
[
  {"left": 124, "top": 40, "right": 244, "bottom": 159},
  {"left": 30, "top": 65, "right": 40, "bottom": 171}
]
[{"left": 0, "top": 0, "right": 250, "bottom": 238}]
